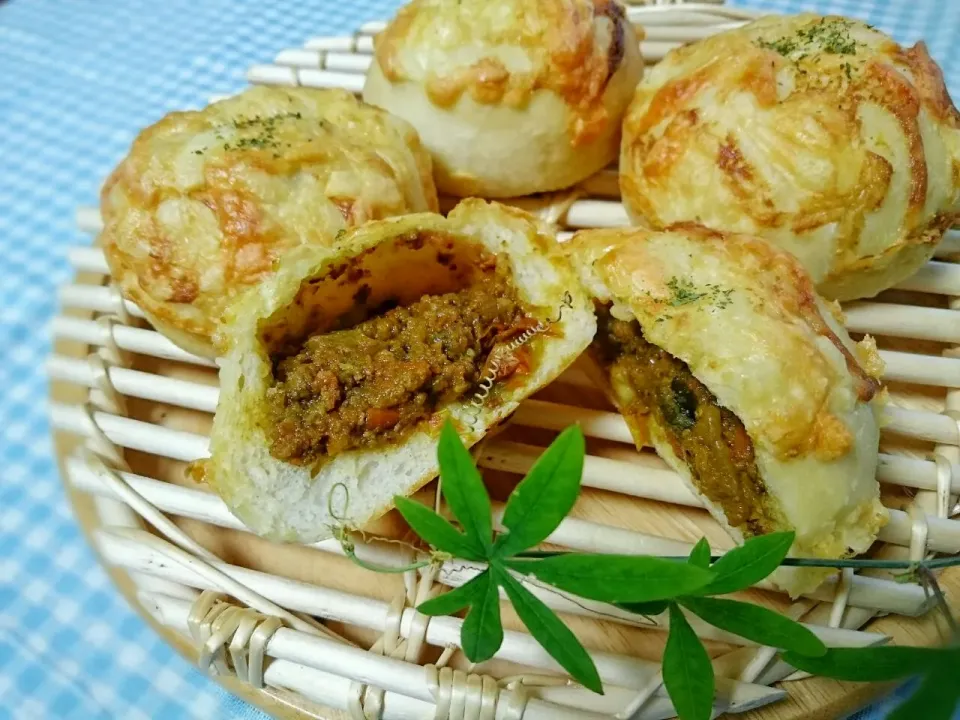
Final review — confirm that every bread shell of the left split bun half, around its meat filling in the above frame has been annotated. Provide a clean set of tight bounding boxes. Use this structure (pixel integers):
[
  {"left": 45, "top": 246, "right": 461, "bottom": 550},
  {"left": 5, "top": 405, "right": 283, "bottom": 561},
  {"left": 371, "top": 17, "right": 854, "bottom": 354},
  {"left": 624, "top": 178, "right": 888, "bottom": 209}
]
[{"left": 205, "top": 200, "right": 596, "bottom": 542}]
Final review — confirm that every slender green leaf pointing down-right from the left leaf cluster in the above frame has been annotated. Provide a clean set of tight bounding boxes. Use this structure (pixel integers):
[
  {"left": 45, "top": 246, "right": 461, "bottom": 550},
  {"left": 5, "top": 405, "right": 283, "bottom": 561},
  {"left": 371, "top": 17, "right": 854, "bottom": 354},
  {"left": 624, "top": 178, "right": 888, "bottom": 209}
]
[{"left": 495, "top": 567, "right": 603, "bottom": 695}]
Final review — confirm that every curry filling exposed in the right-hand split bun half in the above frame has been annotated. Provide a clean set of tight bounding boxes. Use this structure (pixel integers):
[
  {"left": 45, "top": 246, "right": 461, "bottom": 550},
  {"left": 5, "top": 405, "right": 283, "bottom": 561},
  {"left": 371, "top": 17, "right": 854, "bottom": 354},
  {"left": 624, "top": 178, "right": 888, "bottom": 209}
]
[{"left": 594, "top": 307, "right": 773, "bottom": 535}]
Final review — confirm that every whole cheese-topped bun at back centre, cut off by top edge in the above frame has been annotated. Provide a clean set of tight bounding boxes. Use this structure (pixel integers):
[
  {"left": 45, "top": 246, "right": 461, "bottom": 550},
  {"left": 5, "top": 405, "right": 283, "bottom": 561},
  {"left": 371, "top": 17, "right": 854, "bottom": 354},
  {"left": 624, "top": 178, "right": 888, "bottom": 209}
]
[{"left": 363, "top": 0, "right": 643, "bottom": 197}]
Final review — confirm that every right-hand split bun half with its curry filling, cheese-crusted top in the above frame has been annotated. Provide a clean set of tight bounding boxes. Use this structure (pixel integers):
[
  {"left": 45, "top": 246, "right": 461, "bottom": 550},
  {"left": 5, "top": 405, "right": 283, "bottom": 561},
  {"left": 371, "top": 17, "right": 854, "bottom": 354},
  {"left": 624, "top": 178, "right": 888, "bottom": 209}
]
[{"left": 568, "top": 225, "right": 886, "bottom": 594}]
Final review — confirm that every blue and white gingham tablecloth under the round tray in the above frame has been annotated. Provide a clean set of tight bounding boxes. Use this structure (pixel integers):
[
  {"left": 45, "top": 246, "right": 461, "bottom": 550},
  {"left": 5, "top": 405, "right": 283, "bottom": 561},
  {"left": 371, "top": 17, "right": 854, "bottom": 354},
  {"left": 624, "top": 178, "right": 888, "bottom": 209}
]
[{"left": 0, "top": 0, "right": 960, "bottom": 720}]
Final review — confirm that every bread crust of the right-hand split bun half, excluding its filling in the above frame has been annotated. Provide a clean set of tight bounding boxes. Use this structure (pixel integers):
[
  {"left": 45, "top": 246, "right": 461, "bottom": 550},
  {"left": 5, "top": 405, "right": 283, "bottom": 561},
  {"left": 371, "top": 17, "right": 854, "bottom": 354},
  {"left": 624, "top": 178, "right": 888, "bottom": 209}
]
[{"left": 569, "top": 224, "right": 886, "bottom": 592}]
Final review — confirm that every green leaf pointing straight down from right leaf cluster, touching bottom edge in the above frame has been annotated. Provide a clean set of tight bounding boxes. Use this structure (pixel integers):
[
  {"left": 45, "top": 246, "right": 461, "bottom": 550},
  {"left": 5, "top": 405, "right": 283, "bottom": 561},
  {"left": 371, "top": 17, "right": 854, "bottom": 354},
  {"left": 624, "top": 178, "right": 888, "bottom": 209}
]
[{"left": 663, "top": 603, "right": 714, "bottom": 720}]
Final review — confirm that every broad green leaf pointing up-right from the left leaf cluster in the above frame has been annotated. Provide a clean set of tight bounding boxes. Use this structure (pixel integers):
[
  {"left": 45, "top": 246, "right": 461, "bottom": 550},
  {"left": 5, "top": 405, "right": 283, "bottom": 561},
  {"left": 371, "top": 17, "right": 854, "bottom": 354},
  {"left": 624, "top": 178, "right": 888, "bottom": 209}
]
[{"left": 495, "top": 425, "right": 585, "bottom": 557}]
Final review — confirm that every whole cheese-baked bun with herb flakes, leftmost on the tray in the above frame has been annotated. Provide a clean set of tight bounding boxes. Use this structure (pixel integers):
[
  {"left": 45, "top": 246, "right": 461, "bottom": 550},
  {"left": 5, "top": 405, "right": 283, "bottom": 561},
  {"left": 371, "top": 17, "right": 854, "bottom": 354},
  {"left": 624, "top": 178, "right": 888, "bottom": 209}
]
[{"left": 100, "top": 87, "right": 437, "bottom": 357}]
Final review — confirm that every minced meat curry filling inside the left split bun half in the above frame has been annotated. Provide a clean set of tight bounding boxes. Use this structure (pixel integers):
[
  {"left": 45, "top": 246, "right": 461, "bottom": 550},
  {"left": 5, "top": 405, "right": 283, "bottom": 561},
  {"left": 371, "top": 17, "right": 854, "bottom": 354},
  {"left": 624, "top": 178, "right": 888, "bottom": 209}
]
[{"left": 267, "top": 258, "right": 529, "bottom": 464}]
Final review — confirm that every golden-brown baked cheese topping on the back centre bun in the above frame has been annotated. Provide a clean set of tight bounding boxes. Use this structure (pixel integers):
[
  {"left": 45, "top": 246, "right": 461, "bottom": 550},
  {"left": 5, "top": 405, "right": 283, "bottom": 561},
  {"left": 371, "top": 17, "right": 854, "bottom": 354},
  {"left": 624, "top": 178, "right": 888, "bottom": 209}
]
[{"left": 376, "top": 0, "right": 637, "bottom": 145}]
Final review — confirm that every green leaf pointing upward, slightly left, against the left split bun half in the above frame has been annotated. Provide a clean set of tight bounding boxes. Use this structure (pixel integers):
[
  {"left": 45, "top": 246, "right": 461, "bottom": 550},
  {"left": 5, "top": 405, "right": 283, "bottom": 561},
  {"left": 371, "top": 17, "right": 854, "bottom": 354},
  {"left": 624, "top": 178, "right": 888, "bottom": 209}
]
[{"left": 437, "top": 420, "right": 493, "bottom": 557}]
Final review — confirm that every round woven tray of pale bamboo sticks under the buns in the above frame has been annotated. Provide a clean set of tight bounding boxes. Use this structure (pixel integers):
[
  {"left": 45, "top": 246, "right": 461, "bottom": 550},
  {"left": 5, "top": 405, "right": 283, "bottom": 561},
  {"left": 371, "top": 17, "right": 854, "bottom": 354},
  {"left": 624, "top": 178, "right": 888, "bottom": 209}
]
[{"left": 48, "top": 3, "right": 960, "bottom": 720}]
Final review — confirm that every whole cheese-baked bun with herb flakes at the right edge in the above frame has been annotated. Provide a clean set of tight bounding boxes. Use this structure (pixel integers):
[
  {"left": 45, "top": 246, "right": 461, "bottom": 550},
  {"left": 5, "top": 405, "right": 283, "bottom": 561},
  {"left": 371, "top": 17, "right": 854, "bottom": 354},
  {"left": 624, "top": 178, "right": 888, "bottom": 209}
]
[{"left": 620, "top": 15, "right": 960, "bottom": 300}]
